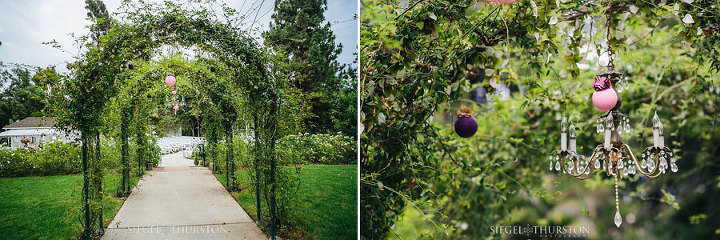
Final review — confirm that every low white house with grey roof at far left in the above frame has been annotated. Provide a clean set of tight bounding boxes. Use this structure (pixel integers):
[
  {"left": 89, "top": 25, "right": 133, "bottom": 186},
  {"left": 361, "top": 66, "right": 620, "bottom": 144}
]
[{"left": 0, "top": 117, "right": 73, "bottom": 148}]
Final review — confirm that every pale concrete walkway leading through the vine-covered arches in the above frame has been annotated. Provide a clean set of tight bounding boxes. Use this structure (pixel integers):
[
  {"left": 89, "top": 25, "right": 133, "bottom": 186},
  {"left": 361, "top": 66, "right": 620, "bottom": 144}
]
[{"left": 103, "top": 152, "right": 267, "bottom": 239}]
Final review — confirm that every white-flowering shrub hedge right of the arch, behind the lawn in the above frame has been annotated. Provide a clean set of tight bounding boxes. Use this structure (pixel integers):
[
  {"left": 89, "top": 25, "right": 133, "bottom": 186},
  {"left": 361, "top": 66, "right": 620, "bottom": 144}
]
[{"left": 276, "top": 134, "right": 357, "bottom": 164}]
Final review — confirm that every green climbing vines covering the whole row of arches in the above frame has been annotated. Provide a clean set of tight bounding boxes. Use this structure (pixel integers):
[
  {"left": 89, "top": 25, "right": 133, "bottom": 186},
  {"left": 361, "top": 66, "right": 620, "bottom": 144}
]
[{"left": 58, "top": 1, "right": 302, "bottom": 239}]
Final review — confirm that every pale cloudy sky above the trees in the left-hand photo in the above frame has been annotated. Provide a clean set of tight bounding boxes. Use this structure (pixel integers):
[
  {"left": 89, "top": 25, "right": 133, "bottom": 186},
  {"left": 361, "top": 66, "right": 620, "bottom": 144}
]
[{"left": 0, "top": 0, "right": 358, "bottom": 72}]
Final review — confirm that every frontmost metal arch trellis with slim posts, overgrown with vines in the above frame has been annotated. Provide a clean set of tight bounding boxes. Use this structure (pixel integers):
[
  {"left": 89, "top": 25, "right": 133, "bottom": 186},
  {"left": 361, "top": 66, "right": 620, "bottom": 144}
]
[{"left": 60, "top": 1, "right": 277, "bottom": 239}]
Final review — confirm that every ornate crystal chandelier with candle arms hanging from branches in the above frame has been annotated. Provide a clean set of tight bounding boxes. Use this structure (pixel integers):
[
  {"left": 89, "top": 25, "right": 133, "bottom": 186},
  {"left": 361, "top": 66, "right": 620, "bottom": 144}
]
[{"left": 549, "top": 8, "right": 678, "bottom": 227}]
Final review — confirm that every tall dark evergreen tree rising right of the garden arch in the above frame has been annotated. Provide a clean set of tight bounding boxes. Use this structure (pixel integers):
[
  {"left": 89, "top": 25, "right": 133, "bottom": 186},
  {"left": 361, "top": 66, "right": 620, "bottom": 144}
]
[{"left": 263, "top": 0, "right": 354, "bottom": 135}]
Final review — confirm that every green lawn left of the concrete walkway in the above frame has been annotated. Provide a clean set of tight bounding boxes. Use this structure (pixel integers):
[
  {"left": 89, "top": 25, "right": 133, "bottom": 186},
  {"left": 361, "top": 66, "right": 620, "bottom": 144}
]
[{"left": 0, "top": 174, "right": 138, "bottom": 239}]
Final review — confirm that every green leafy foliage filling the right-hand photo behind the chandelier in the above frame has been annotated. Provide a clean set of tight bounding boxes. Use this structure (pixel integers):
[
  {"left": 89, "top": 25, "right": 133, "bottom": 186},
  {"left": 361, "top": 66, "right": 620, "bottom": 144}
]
[{"left": 360, "top": 1, "right": 717, "bottom": 239}]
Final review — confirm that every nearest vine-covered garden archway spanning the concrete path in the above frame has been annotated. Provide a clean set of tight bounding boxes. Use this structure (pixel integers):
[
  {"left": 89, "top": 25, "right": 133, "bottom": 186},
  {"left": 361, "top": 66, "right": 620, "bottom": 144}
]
[{"left": 59, "top": 3, "right": 282, "bottom": 239}]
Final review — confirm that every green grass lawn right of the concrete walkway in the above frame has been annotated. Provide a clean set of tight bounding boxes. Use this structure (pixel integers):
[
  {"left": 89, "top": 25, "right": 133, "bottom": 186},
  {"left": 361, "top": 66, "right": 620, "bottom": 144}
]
[{"left": 216, "top": 165, "right": 357, "bottom": 239}]
